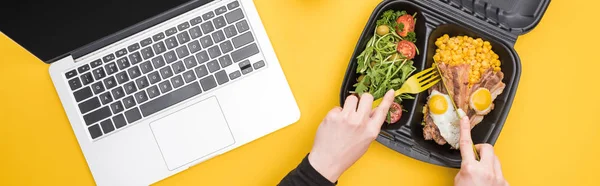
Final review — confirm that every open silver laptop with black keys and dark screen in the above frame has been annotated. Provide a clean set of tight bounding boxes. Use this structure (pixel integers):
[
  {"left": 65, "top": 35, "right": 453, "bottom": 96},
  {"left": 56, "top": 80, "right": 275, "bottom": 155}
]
[{"left": 0, "top": 0, "right": 300, "bottom": 186}]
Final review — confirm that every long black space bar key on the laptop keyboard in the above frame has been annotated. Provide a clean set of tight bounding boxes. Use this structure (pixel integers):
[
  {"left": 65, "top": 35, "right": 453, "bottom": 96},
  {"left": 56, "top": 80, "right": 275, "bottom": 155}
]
[{"left": 140, "top": 82, "right": 202, "bottom": 116}]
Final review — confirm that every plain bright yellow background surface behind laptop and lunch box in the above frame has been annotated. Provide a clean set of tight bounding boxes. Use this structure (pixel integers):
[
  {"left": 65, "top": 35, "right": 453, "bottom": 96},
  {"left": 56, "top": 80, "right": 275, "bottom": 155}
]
[{"left": 0, "top": 0, "right": 600, "bottom": 185}]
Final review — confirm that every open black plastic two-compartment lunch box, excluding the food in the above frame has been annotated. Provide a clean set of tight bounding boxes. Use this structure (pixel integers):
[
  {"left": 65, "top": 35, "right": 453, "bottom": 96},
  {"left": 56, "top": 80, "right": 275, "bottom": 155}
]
[{"left": 340, "top": 0, "right": 550, "bottom": 168}]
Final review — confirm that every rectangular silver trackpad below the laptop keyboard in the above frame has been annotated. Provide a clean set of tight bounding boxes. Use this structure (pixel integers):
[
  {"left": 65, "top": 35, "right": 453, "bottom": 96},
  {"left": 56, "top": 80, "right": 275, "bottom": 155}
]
[{"left": 150, "top": 97, "right": 235, "bottom": 170}]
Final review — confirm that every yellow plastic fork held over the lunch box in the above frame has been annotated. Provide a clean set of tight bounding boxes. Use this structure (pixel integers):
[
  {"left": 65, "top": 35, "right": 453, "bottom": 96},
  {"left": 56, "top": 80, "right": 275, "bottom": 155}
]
[{"left": 373, "top": 67, "right": 441, "bottom": 108}]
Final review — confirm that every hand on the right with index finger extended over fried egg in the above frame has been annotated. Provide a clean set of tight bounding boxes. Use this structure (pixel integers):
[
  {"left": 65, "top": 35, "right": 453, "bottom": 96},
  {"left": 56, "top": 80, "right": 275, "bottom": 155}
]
[{"left": 454, "top": 117, "right": 508, "bottom": 186}]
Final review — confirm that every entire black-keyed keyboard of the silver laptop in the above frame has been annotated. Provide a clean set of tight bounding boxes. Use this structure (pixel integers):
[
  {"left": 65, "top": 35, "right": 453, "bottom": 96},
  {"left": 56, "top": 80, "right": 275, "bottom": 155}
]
[{"left": 65, "top": 1, "right": 265, "bottom": 139}]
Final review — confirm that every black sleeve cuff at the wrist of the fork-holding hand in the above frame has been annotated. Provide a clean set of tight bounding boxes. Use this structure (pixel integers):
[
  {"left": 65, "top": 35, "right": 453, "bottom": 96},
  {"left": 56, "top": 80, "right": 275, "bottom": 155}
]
[{"left": 278, "top": 155, "right": 337, "bottom": 186}]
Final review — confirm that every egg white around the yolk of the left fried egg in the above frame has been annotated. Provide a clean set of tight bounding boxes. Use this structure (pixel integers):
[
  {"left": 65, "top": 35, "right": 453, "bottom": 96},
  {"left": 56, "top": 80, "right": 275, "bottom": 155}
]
[{"left": 429, "top": 90, "right": 466, "bottom": 149}]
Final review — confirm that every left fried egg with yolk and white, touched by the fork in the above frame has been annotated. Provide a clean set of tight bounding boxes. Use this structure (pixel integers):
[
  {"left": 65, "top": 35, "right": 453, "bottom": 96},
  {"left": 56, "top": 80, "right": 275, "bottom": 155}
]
[{"left": 427, "top": 90, "right": 466, "bottom": 149}]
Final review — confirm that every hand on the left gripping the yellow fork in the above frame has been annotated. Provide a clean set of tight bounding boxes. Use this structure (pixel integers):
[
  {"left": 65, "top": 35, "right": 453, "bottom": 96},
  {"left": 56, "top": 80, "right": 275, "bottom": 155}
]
[{"left": 308, "top": 90, "right": 394, "bottom": 182}]
